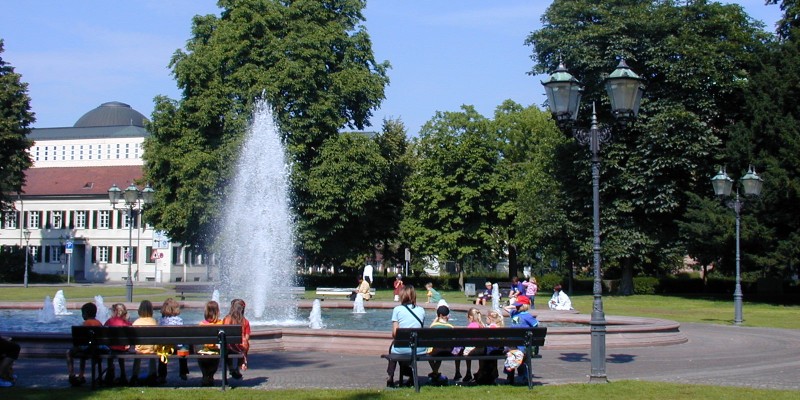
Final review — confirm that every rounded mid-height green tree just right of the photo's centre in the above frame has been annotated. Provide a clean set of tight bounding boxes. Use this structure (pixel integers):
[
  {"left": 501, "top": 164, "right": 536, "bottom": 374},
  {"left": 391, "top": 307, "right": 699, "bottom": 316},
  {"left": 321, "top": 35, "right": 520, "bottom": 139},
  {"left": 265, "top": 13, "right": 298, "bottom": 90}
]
[{"left": 400, "top": 106, "right": 502, "bottom": 263}]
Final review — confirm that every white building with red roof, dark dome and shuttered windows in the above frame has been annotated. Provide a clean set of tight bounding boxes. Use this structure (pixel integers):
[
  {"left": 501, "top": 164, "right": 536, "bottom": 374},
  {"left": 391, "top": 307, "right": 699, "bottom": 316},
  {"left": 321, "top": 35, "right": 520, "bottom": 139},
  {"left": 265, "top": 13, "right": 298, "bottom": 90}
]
[{"left": 0, "top": 102, "right": 211, "bottom": 282}]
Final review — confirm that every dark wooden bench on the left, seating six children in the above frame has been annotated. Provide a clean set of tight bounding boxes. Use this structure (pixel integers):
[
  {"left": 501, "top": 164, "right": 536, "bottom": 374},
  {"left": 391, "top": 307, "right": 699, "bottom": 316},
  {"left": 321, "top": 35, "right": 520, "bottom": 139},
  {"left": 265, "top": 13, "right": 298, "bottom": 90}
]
[{"left": 72, "top": 325, "right": 243, "bottom": 390}]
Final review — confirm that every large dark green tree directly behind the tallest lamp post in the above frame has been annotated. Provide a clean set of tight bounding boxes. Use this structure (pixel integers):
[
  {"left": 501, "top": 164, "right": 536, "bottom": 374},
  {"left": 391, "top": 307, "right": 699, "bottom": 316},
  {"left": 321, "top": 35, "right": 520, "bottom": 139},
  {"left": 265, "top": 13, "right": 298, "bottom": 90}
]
[{"left": 527, "top": 0, "right": 769, "bottom": 294}]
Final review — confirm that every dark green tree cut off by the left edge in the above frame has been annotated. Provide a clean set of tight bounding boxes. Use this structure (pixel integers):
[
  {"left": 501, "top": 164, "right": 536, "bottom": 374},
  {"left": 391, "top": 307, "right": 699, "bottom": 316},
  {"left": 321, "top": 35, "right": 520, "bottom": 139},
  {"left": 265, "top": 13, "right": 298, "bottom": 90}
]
[{"left": 0, "top": 39, "right": 36, "bottom": 211}]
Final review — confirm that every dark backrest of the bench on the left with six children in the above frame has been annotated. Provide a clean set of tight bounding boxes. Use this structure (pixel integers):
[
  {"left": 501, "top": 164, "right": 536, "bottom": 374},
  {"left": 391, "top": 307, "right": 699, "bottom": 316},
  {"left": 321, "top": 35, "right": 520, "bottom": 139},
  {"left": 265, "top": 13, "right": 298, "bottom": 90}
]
[{"left": 72, "top": 325, "right": 242, "bottom": 346}]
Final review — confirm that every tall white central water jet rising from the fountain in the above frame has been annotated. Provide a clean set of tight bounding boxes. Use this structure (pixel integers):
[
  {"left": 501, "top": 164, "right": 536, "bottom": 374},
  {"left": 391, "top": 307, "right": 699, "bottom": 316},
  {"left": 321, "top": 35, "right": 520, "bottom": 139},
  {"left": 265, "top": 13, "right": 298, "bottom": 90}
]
[{"left": 218, "top": 101, "right": 297, "bottom": 321}]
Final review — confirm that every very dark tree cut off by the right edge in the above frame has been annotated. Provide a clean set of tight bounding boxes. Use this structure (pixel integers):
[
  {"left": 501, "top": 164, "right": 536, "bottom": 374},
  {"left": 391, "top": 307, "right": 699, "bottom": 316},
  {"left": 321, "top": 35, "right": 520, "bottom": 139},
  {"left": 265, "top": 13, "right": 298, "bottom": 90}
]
[{"left": 727, "top": 1, "right": 800, "bottom": 277}]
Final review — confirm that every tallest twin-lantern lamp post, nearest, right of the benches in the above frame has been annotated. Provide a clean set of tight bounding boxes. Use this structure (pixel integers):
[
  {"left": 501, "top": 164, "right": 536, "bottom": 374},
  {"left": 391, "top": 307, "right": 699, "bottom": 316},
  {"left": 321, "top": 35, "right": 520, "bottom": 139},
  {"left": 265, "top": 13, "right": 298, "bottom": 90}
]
[{"left": 542, "top": 60, "right": 645, "bottom": 383}]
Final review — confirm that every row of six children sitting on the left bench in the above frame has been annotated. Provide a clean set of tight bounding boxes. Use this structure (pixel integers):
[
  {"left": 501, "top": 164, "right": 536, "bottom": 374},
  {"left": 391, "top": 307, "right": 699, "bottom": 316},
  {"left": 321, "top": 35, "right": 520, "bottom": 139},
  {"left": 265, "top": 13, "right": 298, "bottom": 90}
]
[{"left": 67, "top": 297, "right": 251, "bottom": 386}]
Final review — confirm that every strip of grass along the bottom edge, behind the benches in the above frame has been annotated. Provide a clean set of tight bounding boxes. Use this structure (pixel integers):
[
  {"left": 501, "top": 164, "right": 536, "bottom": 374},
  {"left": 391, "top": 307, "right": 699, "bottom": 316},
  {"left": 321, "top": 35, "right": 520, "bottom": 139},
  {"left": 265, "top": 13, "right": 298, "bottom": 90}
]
[{"left": 6, "top": 381, "right": 798, "bottom": 400}]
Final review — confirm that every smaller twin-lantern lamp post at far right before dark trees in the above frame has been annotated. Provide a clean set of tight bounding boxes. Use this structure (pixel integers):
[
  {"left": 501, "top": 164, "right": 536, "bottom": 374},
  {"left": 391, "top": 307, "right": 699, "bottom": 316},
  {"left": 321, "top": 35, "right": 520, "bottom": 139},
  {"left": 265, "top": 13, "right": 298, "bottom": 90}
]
[{"left": 711, "top": 166, "right": 764, "bottom": 325}]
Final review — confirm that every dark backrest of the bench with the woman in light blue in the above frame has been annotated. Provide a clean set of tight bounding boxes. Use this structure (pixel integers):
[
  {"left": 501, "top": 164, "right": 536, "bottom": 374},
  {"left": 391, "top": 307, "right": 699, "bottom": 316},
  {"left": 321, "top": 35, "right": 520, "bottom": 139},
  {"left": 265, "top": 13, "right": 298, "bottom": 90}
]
[{"left": 394, "top": 327, "right": 547, "bottom": 347}]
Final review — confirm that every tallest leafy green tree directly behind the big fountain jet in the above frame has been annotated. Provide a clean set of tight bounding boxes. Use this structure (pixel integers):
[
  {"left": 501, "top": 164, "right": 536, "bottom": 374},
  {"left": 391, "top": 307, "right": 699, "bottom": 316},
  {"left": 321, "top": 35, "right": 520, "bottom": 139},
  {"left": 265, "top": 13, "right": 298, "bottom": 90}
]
[{"left": 145, "top": 0, "right": 388, "bottom": 248}]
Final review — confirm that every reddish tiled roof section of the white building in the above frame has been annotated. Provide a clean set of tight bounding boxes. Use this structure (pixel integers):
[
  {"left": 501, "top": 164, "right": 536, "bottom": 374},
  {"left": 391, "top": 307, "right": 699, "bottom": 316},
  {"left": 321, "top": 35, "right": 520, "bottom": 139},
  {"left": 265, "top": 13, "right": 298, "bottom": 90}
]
[{"left": 22, "top": 165, "right": 143, "bottom": 196}]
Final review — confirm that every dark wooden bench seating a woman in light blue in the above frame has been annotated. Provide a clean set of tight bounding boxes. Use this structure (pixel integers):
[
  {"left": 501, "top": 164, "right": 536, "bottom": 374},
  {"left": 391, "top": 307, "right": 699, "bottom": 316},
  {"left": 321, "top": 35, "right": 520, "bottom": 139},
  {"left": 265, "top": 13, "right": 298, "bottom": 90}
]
[{"left": 381, "top": 327, "right": 547, "bottom": 392}]
